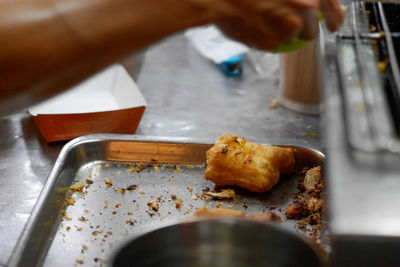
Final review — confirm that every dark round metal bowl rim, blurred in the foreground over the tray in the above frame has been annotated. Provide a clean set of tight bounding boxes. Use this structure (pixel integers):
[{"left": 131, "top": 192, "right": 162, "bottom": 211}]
[{"left": 112, "top": 219, "right": 321, "bottom": 267}]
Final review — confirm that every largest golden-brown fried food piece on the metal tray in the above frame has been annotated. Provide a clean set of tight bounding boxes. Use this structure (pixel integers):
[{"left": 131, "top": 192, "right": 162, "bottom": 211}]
[{"left": 204, "top": 135, "right": 295, "bottom": 192}]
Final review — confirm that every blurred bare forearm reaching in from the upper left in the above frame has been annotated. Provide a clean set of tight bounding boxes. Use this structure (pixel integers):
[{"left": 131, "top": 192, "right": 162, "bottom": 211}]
[{"left": 0, "top": 0, "right": 213, "bottom": 114}]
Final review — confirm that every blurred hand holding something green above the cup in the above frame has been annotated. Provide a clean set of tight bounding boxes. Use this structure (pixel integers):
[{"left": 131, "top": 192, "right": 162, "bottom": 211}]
[{"left": 209, "top": 0, "right": 343, "bottom": 50}]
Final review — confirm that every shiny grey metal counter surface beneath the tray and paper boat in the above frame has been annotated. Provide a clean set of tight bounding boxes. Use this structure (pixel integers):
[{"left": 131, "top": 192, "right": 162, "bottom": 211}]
[{"left": 0, "top": 34, "right": 323, "bottom": 266}]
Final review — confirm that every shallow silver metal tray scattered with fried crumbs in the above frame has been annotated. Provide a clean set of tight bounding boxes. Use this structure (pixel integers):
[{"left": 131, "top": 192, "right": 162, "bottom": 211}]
[{"left": 9, "top": 134, "right": 325, "bottom": 266}]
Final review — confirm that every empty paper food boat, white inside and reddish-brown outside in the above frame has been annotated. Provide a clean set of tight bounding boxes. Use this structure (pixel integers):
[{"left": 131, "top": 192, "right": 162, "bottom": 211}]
[{"left": 29, "top": 65, "right": 146, "bottom": 142}]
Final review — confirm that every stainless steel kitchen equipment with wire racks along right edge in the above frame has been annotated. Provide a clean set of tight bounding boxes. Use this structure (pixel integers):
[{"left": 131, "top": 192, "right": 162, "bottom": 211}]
[{"left": 323, "top": 0, "right": 400, "bottom": 266}]
